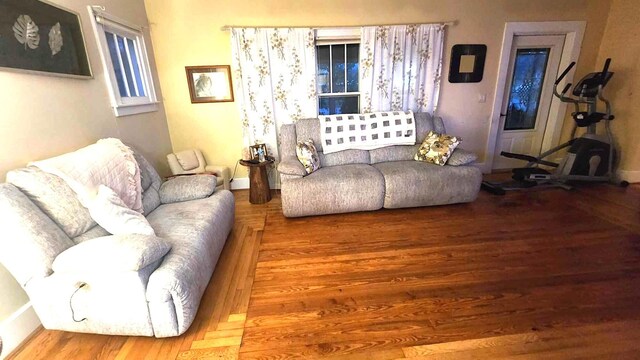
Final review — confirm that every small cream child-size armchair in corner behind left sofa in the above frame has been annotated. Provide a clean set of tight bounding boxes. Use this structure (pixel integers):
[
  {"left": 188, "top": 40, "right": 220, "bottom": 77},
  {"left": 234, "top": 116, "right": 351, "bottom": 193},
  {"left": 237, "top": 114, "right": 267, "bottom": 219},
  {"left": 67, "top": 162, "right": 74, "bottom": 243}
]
[{"left": 167, "top": 149, "right": 231, "bottom": 190}]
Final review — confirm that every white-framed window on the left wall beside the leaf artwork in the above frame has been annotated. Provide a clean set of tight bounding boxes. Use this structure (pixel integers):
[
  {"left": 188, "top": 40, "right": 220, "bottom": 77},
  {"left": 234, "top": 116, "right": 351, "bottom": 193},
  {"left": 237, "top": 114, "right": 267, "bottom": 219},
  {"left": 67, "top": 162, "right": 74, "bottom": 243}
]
[{"left": 89, "top": 7, "right": 158, "bottom": 116}]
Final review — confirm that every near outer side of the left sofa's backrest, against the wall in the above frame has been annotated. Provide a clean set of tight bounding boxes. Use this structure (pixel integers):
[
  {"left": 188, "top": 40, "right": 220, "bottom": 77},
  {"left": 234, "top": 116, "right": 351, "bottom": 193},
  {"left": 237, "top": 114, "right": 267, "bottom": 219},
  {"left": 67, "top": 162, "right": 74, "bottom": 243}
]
[{"left": 0, "top": 183, "right": 75, "bottom": 286}]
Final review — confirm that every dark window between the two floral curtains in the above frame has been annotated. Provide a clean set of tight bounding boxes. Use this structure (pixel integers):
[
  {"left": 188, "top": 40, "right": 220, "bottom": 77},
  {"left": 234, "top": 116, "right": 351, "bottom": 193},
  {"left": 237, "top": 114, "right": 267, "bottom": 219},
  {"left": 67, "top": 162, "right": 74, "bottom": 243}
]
[{"left": 316, "top": 29, "right": 360, "bottom": 115}]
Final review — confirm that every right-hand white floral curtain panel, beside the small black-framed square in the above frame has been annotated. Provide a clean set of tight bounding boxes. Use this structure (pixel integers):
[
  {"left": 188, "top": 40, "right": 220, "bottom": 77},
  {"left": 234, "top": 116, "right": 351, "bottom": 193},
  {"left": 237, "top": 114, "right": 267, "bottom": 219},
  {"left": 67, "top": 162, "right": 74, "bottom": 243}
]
[{"left": 360, "top": 24, "right": 444, "bottom": 113}]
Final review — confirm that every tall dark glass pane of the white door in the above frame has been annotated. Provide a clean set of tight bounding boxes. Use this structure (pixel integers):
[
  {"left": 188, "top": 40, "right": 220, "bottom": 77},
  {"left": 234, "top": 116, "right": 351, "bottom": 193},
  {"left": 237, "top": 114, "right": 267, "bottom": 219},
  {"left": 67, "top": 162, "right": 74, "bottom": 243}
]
[{"left": 504, "top": 48, "right": 551, "bottom": 130}]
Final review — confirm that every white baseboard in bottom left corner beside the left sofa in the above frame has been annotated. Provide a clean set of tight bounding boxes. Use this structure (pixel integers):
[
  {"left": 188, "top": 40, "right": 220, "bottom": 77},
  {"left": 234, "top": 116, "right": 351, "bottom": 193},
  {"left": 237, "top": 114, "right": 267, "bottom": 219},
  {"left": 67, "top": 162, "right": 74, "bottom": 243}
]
[{"left": 0, "top": 302, "right": 40, "bottom": 360}]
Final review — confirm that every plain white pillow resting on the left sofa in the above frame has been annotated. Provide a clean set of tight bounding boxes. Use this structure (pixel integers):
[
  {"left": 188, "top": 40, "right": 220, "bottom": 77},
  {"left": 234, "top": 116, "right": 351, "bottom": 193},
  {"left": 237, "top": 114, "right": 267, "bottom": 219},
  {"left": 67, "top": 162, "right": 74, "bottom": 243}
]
[{"left": 89, "top": 185, "right": 156, "bottom": 236}]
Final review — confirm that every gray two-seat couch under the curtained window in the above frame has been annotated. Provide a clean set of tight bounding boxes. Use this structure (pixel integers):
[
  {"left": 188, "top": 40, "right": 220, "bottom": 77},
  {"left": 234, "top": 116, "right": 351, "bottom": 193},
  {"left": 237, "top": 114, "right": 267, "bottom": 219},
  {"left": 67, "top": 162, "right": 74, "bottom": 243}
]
[{"left": 278, "top": 113, "right": 482, "bottom": 217}]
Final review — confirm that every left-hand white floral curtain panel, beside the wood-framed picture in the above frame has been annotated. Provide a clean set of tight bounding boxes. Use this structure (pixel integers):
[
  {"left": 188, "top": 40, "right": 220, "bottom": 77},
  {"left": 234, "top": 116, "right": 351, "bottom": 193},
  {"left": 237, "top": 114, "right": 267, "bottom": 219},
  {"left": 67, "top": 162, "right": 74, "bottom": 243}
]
[{"left": 231, "top": 28, "right": 317, "bottom": 158}]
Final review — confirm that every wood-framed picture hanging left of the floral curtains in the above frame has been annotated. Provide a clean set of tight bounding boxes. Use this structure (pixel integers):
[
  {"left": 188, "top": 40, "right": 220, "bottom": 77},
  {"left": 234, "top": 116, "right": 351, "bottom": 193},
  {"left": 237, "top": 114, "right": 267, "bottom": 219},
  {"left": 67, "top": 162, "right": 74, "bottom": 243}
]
[{"left": 185, "top": 65, "right": 233, "bottom": 104}]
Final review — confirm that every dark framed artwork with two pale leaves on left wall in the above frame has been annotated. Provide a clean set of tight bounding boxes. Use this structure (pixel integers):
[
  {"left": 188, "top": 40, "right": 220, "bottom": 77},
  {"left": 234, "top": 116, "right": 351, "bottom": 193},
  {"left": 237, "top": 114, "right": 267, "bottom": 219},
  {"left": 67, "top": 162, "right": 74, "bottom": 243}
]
[{"left": 0, "top": 0, "right": 92, "bottom": 78}]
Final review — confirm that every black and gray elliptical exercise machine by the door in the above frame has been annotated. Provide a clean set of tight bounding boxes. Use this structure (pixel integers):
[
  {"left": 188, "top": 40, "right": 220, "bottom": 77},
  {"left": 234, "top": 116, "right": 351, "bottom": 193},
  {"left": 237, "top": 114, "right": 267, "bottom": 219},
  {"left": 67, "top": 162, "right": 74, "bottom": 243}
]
[{"left": 482, "top": 59, "right": 629, "bottom": 195}]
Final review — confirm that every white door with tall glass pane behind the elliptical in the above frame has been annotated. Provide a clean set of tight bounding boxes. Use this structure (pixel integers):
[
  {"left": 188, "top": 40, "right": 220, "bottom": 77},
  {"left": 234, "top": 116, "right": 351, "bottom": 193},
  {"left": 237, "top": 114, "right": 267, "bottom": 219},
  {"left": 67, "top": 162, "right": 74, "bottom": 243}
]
[{"left": 493, "top": 35, "right": 564, "bottom": 169}]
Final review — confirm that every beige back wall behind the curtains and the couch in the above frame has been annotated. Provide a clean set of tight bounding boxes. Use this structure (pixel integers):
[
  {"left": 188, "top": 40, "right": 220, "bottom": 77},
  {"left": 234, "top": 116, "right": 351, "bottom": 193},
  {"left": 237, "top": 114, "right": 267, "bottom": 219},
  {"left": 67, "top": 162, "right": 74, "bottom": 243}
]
[{"left": 145, "top": 0, "right": 609, "bottom": 176}]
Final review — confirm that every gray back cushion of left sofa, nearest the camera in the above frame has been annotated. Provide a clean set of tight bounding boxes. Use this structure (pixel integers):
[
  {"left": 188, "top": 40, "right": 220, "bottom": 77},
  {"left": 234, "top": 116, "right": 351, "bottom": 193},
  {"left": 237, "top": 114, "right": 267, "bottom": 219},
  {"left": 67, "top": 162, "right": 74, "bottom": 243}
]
[{"left": 7, "top": 166, "right": 96, "bottom": 238}]
